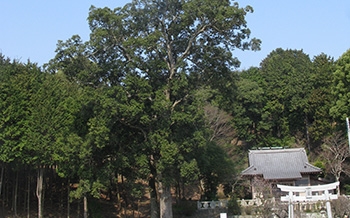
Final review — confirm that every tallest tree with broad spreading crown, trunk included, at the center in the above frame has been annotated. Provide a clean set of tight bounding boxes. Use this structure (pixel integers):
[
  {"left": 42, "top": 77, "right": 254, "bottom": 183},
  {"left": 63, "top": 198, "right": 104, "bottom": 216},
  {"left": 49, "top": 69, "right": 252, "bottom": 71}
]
[{"left": 48, "top": 0, "right": 260, "bottom": 217}]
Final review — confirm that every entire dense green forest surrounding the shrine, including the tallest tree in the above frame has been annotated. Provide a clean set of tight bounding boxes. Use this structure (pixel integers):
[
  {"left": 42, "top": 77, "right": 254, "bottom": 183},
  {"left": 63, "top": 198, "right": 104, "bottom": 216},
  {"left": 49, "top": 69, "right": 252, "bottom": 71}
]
[{"left": 0, "top": 0, "right": 350, "bottom": 218}]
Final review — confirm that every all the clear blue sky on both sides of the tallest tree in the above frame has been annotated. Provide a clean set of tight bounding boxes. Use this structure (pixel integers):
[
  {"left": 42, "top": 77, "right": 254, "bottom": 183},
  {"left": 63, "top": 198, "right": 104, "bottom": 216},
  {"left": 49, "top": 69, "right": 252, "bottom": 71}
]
[{"left": 0, "top": 0, "right": 350, "bottom": 69}]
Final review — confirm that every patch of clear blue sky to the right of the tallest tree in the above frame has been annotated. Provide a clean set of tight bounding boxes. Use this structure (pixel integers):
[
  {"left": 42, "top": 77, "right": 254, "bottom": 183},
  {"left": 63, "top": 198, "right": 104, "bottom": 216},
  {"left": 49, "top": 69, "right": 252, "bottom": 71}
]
[{"left": 236, "top": 0, "right": 350, "bottom": 68}]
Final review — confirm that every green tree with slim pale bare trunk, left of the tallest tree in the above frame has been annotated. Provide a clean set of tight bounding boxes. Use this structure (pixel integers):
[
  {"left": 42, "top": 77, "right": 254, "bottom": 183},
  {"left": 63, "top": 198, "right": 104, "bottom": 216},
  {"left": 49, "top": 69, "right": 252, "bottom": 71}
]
[{"left": 19, "top": 74, "right": 80, "bottom": 217}]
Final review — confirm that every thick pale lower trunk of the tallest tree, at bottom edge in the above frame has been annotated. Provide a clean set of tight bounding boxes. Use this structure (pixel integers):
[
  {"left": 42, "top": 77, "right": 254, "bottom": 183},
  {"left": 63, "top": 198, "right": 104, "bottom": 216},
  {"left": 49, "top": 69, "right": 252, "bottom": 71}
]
[{"left": 159, "top": 182, "right": 173, "bottom": 218}]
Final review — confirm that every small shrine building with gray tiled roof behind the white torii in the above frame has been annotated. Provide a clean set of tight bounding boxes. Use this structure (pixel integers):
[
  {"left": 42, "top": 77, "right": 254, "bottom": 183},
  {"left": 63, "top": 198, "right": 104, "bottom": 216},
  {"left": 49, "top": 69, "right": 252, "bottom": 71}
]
[{"left": 241, "top": 148, "right": 322, "bottom": 199}]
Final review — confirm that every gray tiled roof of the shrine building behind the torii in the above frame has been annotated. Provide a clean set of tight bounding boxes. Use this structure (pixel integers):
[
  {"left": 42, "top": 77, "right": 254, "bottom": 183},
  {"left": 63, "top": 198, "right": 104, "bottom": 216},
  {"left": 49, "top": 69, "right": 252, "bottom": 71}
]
[{"left": 242, "top": 148, "right": 321, "bottom": 180}]
